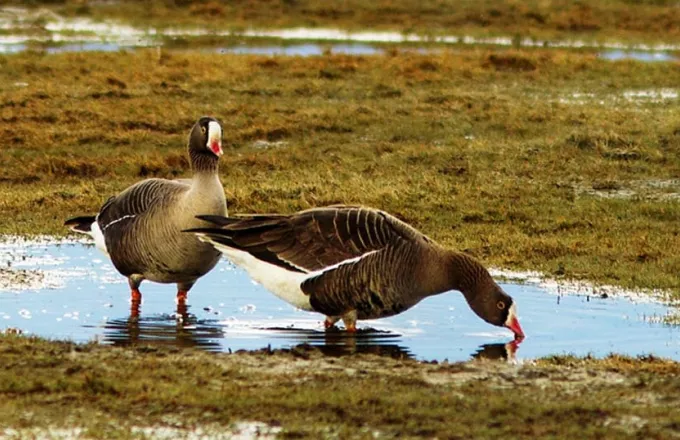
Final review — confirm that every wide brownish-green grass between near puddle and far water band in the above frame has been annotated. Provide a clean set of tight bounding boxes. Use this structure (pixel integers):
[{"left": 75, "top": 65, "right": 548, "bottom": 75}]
[{"left": 0, "top": 49, "right": 680, "bottom": 293}]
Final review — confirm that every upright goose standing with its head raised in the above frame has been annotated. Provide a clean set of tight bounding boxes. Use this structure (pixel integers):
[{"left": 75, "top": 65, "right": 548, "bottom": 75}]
[{"left": 65, "top": 117, "right": 227, "bottom": 310}]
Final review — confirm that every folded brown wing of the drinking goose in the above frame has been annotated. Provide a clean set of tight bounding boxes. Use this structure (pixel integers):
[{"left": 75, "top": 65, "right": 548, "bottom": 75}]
[{"left": 191, "top": 206, "right": 428, "bottom": 273}]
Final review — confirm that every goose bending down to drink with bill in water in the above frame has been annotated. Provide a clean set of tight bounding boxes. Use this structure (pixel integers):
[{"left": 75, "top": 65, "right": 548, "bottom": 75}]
[{"left": 188, "top": 206, "right": 524, "bottom": 340}]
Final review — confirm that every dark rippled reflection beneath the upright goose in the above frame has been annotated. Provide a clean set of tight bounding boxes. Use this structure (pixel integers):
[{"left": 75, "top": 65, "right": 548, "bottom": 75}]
[{"left": 103, "top": 304, "right": 224, "bottom": 351}]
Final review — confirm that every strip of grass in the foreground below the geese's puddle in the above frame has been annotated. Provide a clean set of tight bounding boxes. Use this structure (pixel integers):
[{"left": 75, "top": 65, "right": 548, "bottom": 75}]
[{"left": 0, "top": 336, "right": 680, "bottom": 438}]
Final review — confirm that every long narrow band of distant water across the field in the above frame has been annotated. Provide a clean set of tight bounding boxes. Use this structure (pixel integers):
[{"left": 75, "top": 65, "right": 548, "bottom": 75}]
[{"left": 0, "top": 7, "right": 680, "bottom": 62}]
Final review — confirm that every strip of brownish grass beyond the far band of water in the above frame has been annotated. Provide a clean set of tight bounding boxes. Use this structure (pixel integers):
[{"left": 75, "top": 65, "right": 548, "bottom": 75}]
[{"left": 1, "top": 0, "right": 680, "bottom": 43}]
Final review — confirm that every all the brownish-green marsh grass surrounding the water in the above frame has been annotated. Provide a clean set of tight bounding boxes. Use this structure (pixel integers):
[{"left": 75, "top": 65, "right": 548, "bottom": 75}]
[{"left": 0, "top": 1, "right": 680, "bottom": 438}]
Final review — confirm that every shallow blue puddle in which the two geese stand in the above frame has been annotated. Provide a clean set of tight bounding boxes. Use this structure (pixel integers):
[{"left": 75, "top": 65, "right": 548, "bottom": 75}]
[{"left": 0, "top": 244, "right": 680, "bottom": 360}]
